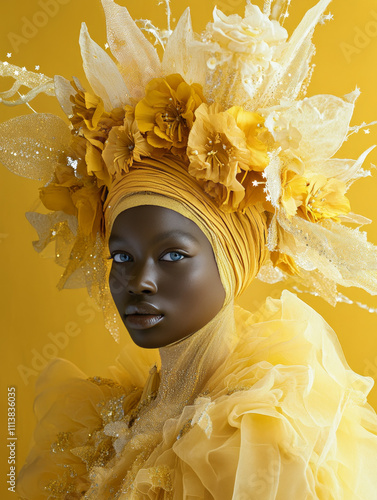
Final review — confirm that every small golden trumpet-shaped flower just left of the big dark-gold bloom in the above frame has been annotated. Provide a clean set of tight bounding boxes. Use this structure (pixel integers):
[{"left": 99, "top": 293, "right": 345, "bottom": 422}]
[{"left": 102, "top": 107, "right": 155, "bottom": 175}]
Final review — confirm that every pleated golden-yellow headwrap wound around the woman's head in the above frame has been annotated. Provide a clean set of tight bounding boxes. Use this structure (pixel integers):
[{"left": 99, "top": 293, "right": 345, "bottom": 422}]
[{"left": 105, "top": 157, "right": 267, "bottom": 303}]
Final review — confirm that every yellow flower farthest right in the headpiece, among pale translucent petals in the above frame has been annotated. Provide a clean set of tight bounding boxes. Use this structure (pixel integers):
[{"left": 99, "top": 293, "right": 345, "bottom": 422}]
[{"left": 281, "top": 170, "right": 351, "bottom": 222}]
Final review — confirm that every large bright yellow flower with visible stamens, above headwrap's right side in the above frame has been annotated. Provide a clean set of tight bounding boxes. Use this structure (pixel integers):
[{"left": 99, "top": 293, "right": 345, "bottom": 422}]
[{"left": 187, "top": 103, "right": 268, "bottom": 211}]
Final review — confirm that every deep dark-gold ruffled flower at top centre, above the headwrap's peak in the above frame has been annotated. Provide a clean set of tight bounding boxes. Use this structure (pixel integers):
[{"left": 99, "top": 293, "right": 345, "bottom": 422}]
[{"left": 135, "top": 75, "right": 204, "bottom": 155}]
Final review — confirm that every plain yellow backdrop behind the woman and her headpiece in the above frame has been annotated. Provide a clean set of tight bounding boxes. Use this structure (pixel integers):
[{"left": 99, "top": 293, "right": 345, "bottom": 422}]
[{"left": 0, "top": 0, "right": 377, "bottom": 498}]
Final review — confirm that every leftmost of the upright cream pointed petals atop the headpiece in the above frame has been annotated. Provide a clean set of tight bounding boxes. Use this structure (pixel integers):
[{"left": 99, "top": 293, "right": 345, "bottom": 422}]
[{"left": 80, "top": 23, "right": 129, "bottom": 111}]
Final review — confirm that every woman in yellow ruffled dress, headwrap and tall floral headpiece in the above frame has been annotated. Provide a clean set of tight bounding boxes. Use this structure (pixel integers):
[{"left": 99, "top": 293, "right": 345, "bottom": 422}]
[{"left": 1, "top": 0, "right": 377, "bottom": 499}]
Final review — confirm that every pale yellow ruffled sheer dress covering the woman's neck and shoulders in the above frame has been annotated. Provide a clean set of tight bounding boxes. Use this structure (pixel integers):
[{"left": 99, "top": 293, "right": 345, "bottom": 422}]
[{"left": 18, "top": 291, "right": 377, "bottom": 500}]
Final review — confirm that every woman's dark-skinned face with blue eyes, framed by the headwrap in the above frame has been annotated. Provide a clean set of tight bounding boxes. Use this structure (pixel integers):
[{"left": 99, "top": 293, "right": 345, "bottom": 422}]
[{"left": 109, "top": 206, "right": 225, "bottom": 348}]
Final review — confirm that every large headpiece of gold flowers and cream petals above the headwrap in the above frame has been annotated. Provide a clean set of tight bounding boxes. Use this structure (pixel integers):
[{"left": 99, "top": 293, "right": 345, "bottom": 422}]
[{"left": 0, "top": 0, "right": 377, "bottom": 320}]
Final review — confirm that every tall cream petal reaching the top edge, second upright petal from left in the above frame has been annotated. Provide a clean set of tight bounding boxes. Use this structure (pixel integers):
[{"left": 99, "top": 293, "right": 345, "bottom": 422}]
[{"left": 102, "top": 0, "right": 161, "bottom": 99}]
